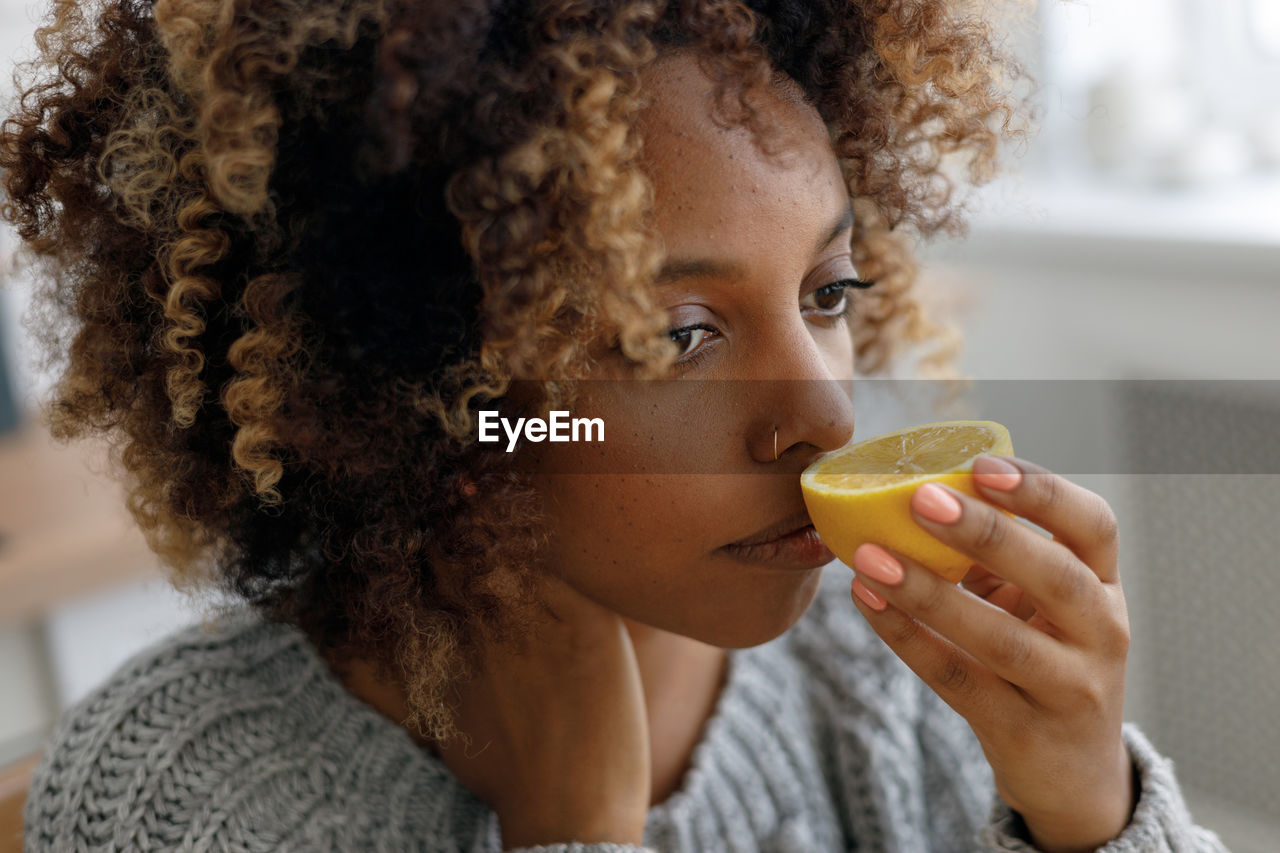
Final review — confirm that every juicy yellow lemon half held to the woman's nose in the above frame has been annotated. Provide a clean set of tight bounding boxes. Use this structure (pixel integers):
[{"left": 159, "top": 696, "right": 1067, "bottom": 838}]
[{"left": 800, "top": 420, "right": 1014, "bottom": 583}]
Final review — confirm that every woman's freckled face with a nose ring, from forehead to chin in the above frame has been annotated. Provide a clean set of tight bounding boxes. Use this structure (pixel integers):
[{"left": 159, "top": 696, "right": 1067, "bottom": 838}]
[{"left": 522, "top": 53, "right": 858, "bottom": 648}]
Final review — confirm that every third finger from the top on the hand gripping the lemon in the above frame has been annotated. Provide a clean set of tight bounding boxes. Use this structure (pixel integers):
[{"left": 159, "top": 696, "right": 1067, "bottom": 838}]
[{"left": 854, "top": 544, "right": 1070, "bottom": 699}]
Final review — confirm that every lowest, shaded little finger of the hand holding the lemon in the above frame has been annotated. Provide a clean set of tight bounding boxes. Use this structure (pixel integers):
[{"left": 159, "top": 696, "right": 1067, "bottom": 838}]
[{"left": 852, "top": 578, "right": 1019, "bottom": 725}]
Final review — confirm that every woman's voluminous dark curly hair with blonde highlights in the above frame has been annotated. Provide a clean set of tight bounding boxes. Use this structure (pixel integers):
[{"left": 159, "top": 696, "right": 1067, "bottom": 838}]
[{"left": 0, "top": 0, "right": 1021, "bottom": 739}]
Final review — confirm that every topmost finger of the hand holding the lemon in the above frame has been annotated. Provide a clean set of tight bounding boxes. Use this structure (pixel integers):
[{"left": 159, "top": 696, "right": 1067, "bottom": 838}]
[{"left": 973, "top": 456, "right": 1120, "bottom": 584}]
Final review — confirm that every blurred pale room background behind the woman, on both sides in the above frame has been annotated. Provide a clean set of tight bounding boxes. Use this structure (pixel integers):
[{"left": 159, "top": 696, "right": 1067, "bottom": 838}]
[{"left": 0, "top": 0, "right": 1280, "bottom": 853}]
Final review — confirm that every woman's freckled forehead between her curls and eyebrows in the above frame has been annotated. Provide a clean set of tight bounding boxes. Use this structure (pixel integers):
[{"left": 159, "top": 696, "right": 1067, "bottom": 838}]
[{"left": 639, "top": 53, "right": 847, "bottom": 254}]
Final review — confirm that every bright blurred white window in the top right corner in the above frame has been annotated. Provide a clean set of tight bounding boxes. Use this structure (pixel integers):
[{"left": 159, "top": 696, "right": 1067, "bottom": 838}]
[{"left": 1037, "top": 0, "right": 1280, "bottom": 186}]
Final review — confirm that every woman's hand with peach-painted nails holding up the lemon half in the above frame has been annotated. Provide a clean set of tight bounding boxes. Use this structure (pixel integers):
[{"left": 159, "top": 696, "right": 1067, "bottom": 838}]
[{"left": 852, "top": 457, "right": 1135, "bottom": 853}]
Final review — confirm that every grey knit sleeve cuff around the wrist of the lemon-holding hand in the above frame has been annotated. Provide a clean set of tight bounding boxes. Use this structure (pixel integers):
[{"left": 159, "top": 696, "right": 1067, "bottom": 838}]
[{"left": 982, "top": 722, "right": 1229, "bottom": 853}]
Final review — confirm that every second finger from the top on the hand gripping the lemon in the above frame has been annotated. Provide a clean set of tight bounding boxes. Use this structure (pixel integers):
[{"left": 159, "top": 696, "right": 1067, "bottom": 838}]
[{"left": 911, "top": 483, "right": 1105, "bottom": 639}]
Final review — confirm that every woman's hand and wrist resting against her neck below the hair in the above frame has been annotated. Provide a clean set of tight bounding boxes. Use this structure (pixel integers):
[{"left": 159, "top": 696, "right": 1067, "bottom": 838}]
[{"left": 430, "top": 575, "right": 650, "bottom": 849}]
